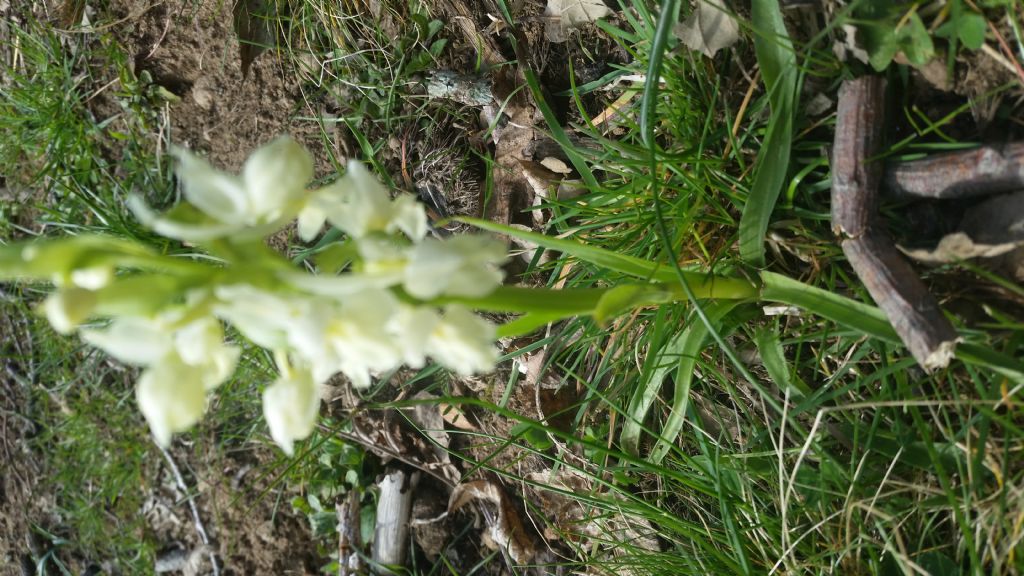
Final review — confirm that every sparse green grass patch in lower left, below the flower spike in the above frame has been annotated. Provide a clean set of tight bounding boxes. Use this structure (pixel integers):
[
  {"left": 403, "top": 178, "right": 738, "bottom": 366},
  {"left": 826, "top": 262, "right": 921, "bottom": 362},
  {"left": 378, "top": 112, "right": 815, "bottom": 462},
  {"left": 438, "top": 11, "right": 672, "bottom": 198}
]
[{"left": 0, "top": 288, "right": 159, "bottom": 573}]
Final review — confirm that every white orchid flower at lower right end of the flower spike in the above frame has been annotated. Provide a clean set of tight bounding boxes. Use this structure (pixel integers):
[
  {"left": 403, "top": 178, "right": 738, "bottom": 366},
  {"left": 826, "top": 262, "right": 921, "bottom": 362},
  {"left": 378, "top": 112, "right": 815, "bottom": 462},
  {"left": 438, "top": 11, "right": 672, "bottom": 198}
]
[{"left": 426, "top": 305, "right": 498, "bottom": 376}]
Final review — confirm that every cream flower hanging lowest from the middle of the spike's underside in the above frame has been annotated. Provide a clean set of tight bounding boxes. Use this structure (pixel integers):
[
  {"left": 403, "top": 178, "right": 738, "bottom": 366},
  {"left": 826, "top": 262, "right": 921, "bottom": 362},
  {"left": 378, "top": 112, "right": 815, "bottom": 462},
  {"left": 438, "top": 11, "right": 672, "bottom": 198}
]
[{"left": 263, "top": 362, "right": 321, "bottom": 455}]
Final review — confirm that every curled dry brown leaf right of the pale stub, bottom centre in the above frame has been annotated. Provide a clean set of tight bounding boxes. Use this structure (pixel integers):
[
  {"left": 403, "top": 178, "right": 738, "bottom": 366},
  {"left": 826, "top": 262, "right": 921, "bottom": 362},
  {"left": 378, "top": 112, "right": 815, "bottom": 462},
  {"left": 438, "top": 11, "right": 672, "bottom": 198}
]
[{"left": 449, "top": 480, "right": 537, "bottom": 564}]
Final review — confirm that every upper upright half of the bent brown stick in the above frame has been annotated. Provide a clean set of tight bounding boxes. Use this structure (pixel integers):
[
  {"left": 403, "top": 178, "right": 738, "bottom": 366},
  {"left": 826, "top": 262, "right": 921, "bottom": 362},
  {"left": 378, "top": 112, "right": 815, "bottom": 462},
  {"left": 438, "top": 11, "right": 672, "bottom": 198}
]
[{"left": 831, "top": 76, "right": 886, "bottom": 238}]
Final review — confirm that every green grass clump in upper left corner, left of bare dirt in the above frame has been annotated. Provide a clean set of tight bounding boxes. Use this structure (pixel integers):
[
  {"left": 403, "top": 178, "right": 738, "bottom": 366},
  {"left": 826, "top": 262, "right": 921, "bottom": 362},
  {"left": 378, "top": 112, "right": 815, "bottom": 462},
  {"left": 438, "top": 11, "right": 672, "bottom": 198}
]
[{"left": 0, "top": 17, "right": 169, "bottom": 239}]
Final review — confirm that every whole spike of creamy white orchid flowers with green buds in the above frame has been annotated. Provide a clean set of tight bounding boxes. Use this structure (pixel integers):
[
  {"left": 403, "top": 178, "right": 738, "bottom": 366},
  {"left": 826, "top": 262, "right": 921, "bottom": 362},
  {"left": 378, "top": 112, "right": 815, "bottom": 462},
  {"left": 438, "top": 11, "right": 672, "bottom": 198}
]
[{"left": 0, "top": 136, "right": 507, "bottom": 453}]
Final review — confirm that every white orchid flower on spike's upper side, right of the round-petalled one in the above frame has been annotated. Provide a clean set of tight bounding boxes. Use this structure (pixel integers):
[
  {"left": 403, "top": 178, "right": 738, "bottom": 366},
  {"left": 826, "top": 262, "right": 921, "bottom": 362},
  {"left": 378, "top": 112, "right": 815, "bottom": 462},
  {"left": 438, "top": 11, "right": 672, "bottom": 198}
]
[{"left": 299, "top": 160, "right": 427, "bottom": 242}]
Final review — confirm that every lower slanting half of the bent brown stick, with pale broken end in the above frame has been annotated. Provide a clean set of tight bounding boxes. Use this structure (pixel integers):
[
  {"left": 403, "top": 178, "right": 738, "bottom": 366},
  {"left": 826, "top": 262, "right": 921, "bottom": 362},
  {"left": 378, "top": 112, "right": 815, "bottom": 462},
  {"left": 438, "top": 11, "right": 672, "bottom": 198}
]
[{"left": 843, "top": 232, "right": 958, "bottom": 372}]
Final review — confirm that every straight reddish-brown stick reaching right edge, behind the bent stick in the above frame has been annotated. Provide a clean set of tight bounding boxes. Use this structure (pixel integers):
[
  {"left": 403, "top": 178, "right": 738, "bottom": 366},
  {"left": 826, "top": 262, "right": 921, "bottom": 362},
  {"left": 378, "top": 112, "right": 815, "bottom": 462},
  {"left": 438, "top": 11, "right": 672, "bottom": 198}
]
[{"left": 883, "top": 142, "right": 1024, "bottom": 198}]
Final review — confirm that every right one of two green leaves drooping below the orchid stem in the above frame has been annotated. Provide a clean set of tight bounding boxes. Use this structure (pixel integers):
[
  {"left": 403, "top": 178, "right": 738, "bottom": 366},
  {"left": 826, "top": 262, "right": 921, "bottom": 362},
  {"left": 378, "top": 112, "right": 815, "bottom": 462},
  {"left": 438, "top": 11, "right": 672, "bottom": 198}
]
[{"left": 651, "top": 301, "right": 739, "bottom": 464}]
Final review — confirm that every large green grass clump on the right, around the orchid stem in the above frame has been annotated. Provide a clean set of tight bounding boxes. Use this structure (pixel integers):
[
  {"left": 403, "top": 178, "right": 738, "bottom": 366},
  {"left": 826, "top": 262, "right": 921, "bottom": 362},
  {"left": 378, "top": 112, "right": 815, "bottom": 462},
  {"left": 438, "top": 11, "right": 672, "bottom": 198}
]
[{"left": 468, "top": 1, "right": 1024, "bottom": 574}]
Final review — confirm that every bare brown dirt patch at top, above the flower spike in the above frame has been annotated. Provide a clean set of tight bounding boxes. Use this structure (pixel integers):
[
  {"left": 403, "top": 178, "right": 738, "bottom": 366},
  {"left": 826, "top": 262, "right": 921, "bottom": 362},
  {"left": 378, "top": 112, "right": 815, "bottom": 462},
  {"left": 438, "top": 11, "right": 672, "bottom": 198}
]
[{"left": 99, "top": 0, "right": 317, "bottom": 169}]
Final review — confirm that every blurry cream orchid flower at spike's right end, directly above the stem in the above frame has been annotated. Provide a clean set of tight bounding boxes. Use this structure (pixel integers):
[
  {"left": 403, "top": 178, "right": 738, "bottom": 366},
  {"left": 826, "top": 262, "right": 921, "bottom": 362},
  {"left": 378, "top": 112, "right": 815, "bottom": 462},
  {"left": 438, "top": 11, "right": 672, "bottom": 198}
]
[{"left": 403, "top": 236, "right": 508, "bottom": 300}]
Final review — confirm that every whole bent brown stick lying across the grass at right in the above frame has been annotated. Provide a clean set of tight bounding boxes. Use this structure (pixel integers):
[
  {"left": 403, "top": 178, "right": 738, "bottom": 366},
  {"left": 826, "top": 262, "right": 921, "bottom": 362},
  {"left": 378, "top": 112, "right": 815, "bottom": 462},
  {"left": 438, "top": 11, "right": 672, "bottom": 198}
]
[{"left": 831, "top": 77, "right": 958, "bottom": 371}]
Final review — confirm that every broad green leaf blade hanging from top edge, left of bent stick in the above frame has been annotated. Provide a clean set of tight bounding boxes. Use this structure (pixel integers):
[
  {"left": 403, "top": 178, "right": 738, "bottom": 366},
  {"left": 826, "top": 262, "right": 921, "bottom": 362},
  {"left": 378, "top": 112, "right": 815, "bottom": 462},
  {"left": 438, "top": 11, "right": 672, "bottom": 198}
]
[{"left": 739, "top": 0, "right": 798, "bottom": 265}]
